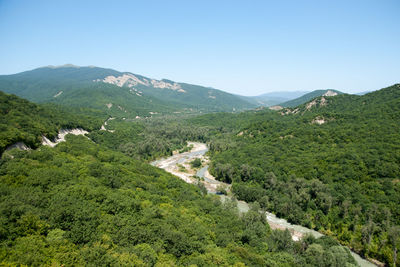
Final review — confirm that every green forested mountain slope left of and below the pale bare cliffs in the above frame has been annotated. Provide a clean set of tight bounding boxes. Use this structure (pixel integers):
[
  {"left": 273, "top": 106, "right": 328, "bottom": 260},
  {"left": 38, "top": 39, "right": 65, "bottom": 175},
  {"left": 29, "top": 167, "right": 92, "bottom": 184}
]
[{"left": 0, "top": 66, "right": 187, "bottom": 118}]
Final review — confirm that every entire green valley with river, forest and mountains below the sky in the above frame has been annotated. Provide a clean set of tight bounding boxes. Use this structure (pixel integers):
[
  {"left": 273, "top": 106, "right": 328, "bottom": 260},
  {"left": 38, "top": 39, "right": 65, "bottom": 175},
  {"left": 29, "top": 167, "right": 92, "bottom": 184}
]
[{"left": 0, "top": 66, "right": 400, "bottom": 266}]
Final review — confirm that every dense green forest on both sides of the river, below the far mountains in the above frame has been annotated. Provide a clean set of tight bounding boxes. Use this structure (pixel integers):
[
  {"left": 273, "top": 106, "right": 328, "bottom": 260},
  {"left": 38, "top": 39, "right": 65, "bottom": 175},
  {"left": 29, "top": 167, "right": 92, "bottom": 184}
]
[{"left": 0, "top": 85, "right": 400, "bottom": 266}]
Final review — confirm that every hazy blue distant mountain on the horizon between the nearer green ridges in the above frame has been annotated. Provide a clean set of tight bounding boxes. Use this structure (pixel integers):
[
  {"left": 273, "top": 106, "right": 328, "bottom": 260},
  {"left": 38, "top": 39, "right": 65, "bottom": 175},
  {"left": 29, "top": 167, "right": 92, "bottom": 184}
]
[{"left": 241, "top": 91, "right": 308, "bottom": 107}]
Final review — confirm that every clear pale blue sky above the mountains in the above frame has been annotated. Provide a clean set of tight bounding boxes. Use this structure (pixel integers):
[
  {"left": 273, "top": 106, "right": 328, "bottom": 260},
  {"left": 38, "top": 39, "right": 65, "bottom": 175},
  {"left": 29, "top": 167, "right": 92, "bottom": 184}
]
[{"left": 0, "top": 0, "right": 400, "bottom": 95}]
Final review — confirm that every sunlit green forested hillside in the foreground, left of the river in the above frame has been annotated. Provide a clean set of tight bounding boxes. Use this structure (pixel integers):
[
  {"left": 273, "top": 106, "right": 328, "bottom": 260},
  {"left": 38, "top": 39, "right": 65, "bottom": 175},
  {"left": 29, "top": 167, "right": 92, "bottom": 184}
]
[{"left": 0, "top": 95, "right": 355, "bottom": 266}]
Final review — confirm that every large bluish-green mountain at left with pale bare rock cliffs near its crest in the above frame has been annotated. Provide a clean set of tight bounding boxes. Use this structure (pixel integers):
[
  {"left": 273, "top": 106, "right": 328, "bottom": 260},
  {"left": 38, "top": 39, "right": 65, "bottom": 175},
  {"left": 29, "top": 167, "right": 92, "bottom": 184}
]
[{"left": 0, "top": 65, "right": 253, "bottom": 117}]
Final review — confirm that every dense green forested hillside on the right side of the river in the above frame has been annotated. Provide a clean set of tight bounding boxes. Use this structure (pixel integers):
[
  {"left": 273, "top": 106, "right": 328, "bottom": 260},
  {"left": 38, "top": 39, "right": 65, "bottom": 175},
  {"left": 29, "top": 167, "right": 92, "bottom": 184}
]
[{"left": 190, "top": 85, "right": 400, "bottom": 264}]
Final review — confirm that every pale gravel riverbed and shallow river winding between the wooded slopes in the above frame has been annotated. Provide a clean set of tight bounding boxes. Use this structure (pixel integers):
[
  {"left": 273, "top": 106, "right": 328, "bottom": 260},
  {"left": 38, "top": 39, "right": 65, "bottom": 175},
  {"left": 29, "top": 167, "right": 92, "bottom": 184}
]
[{"left": 151, "top": 142, "right": 376, "bottom": 267}]
